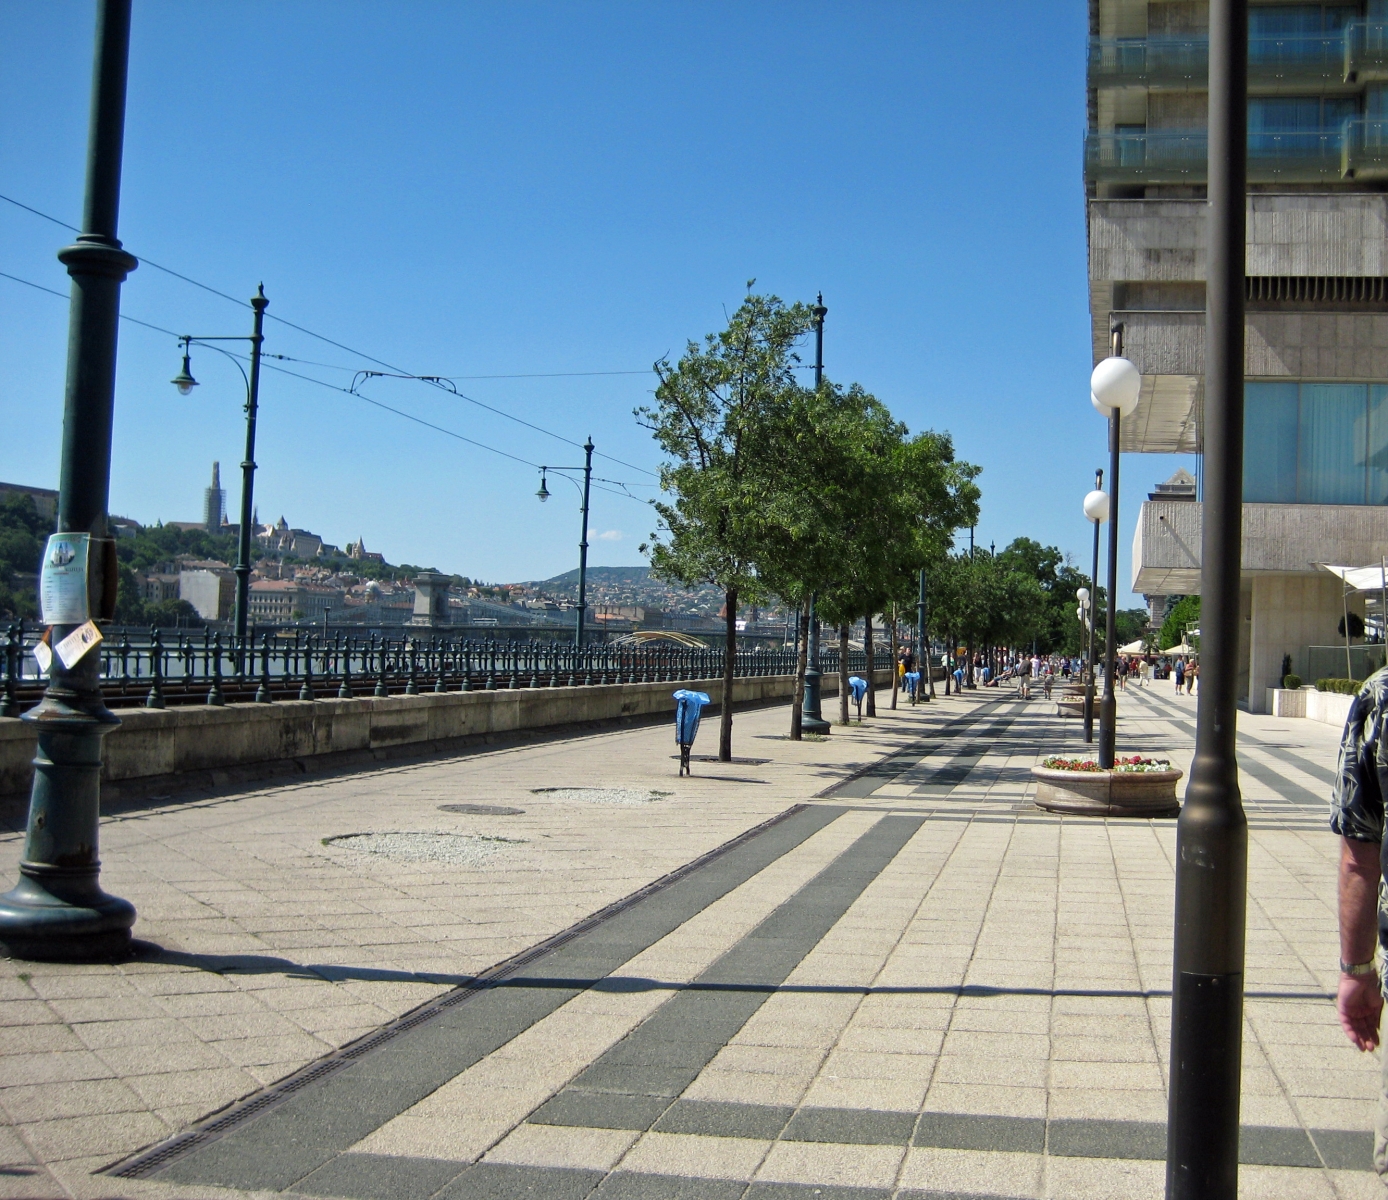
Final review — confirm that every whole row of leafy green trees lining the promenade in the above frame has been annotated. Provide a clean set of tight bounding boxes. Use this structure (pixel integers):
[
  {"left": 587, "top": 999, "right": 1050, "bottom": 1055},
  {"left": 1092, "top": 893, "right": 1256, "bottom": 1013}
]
[{"left": 636, "top": 284, "right": 1145, "bottom": 762}]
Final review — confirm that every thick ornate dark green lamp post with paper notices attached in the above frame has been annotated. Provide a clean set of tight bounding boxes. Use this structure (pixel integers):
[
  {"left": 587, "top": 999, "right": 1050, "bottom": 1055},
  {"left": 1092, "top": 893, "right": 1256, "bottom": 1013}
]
[{"left": 0, "top": 0, "right": 137, "bottom": 961}]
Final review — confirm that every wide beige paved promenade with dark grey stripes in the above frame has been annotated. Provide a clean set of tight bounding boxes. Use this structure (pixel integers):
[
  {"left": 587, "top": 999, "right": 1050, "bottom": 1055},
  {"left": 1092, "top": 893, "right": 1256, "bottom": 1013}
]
[{"left": 0, "top": 684, "right": 1382, "bottom": 1200}]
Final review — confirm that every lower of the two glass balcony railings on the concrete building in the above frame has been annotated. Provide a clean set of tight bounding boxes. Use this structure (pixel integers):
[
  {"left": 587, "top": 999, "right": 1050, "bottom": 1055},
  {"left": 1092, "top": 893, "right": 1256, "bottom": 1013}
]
[{"left": 1084, "top": 126, "right": 1365, "bottom": 185}]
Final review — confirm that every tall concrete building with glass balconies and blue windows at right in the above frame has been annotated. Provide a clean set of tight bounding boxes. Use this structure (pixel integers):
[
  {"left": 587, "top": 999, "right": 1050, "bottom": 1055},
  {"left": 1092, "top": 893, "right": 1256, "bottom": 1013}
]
[{"left": 1084, "top": 0, "right": 1388, "bottom": 701}]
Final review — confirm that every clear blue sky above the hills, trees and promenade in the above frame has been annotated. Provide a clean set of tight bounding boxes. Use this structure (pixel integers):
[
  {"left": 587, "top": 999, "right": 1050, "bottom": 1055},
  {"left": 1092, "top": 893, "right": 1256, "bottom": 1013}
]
[{"left": 0, "top": 0, "right": 1176, "bottom": 602}]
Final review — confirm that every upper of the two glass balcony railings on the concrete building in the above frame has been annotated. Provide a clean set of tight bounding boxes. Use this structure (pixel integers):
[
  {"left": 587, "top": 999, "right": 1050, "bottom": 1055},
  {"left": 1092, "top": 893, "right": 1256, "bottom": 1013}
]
[{"left": 1090, "top": 21, "right": 1388, "bottom": 90}]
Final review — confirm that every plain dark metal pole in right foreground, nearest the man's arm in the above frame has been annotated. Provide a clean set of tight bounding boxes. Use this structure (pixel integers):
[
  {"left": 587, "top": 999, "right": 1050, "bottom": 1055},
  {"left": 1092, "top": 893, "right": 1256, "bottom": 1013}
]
[{"left": 1166, "top": 0, "right": 1248, "bottom": 1200}]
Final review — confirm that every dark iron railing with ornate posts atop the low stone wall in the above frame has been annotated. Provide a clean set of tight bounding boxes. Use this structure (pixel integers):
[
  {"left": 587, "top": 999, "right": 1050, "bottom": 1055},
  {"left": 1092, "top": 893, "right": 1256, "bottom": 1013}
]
[{"left": 0, "top": 623, "right": 891, "bottom": 717}]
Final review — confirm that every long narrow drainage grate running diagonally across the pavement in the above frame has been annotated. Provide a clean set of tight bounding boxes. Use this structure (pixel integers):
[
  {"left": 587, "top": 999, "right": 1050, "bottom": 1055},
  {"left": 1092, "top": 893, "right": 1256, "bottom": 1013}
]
[{"left": 103, "top": 805, "right": 808, "bottom": 1179}]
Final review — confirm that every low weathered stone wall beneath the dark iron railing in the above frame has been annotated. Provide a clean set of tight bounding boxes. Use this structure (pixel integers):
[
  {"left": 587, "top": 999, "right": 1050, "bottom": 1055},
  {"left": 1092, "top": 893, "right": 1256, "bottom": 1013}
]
[{"left": 0, "top": 671, "right": 891, "bottom": 795}]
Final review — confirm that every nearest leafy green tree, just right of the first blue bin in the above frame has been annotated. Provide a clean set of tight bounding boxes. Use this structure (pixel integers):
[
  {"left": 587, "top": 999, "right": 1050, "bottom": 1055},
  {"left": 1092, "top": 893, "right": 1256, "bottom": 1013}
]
[{"left": 636, "top": 283, "right": 812, "bottom": 762}]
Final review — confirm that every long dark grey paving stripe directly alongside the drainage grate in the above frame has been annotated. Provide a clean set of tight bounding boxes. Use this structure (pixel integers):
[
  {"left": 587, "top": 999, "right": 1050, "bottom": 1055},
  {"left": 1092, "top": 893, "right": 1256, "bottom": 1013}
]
[{"left": 127, "top": 805, "right": 844, "bottom": 1190}]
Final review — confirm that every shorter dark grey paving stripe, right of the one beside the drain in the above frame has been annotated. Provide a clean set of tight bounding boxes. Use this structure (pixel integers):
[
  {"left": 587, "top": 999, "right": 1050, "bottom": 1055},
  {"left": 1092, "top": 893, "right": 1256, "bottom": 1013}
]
[{"left": 529, "top": 816, "right": 924, "bottom": 1132}]
